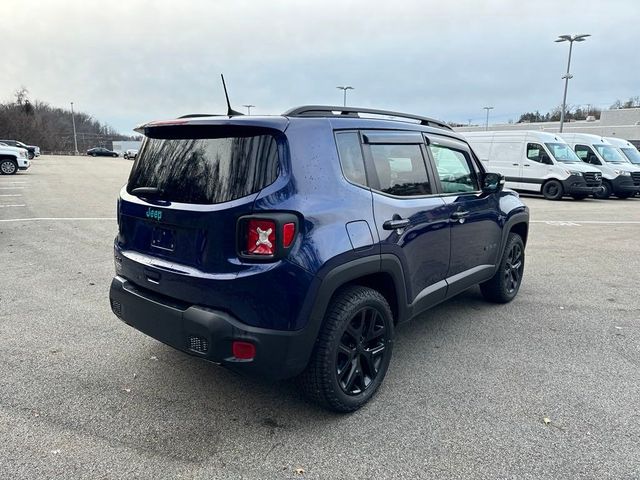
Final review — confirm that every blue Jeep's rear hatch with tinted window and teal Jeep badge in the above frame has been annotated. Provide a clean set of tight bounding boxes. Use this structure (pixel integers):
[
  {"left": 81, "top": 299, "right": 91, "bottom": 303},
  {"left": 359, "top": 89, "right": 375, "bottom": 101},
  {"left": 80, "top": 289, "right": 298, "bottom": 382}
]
[{"left": 116, "top": 119, "right": 285, "bottom": 290}]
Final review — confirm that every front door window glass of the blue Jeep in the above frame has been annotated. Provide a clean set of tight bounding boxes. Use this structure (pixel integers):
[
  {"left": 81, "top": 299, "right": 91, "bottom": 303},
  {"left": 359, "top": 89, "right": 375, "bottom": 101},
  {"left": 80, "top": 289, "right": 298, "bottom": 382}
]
[{"left": 429, "top": 144, "right": 480, "bottom": 193}]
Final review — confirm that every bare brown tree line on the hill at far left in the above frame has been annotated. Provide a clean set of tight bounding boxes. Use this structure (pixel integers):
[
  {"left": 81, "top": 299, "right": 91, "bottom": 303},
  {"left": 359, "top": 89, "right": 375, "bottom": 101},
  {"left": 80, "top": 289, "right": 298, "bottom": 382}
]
[{"left": 0, "top": 87, "right": 141, "bottom": 153}]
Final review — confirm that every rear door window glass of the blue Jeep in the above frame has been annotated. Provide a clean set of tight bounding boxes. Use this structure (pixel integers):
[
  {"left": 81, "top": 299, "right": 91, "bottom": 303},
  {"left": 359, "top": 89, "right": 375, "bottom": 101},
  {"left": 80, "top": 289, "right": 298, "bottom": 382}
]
[{"left": 370, "top": 144, "right": 432, "bottom": 197}]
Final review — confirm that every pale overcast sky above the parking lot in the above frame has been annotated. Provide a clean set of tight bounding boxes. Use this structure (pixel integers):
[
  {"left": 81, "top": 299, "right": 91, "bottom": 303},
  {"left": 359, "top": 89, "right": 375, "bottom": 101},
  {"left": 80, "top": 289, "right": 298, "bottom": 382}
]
[{"left": 5, "top": 0, "right": 640, "bottom": 133}]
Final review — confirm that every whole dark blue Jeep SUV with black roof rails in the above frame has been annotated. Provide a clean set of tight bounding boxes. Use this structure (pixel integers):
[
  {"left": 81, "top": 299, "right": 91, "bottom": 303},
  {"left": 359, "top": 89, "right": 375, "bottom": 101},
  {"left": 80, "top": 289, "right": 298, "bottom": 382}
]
[{"left": 110, "top": 106, "right": 529, "bottom": 412}]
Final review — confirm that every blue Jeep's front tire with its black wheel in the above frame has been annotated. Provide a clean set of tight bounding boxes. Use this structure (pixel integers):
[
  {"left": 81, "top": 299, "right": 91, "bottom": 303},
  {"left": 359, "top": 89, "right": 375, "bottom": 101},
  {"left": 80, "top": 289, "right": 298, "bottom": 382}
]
[{"left": 480, "top": 232, "right": 524, "bottom": 303}]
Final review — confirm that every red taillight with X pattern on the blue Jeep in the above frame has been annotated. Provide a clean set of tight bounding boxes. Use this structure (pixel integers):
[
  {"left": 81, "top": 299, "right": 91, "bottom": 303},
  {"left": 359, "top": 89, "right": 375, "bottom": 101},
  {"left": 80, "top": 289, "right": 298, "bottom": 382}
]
[{"left": 238, "top": 212, "right": 298, "bottom": 261}]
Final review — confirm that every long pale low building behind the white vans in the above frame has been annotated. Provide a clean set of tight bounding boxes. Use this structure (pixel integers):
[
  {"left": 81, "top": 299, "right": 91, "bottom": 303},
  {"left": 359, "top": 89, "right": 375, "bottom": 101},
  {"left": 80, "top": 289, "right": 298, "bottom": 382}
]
[{"left": 454, "top": 108, "right": 640, "bottom": 146}]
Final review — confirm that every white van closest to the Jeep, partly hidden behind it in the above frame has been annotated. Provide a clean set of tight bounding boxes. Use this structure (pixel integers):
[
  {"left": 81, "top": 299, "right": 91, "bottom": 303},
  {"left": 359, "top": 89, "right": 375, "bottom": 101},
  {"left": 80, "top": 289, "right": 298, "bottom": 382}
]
[{"left": 463, "top": 130, "right": 602, "bottom": 200}]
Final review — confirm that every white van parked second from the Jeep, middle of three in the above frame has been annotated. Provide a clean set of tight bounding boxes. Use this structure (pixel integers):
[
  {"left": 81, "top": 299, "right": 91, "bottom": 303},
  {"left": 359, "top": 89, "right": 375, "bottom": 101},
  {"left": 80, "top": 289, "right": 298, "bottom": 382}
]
[{"left": 561, "top": 133, "right": 640, "bottom": 198}]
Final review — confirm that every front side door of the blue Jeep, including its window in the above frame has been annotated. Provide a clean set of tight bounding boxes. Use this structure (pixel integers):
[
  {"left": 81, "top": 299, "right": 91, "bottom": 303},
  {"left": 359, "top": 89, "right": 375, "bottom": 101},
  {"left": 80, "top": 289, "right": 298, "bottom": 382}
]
[{"left": 427, "top": 134, "right": 504, "bottom": 296}]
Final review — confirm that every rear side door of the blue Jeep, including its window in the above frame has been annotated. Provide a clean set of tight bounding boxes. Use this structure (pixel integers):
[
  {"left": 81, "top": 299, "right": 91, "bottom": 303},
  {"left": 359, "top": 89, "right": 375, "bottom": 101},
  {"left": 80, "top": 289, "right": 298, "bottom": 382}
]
[{"left": 362, "top": 130, "right": 450, "bottom": 313}]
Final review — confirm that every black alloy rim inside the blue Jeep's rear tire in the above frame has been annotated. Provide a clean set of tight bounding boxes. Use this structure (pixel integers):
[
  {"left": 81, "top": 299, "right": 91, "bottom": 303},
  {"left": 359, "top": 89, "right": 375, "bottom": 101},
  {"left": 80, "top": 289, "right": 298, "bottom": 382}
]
[{"left": 336, "top": 307, "right": 387, "bottom": 395}]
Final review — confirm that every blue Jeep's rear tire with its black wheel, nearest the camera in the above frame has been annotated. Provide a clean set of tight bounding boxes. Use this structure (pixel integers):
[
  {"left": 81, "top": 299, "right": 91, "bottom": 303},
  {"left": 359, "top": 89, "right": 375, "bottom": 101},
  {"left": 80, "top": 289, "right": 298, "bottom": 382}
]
[{"left": 298, "top": 285, "right": 393, "bottom": 413}]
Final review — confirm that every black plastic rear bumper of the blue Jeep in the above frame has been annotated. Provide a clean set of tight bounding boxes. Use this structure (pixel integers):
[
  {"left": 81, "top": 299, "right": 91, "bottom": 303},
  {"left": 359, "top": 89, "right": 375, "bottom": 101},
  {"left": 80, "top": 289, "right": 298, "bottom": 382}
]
[{"left": 109, "top": 276, "right": 317, "bottom": 379}]
